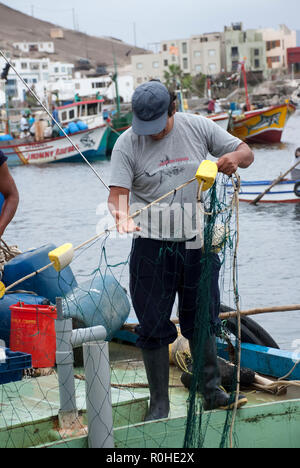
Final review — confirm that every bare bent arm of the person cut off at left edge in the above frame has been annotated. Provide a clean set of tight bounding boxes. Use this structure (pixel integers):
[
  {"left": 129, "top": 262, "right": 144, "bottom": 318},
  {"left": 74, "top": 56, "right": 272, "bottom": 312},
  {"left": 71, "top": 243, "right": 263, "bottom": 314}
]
[{"left": 0, "top": 163, "right": 19, "bottom": 237}]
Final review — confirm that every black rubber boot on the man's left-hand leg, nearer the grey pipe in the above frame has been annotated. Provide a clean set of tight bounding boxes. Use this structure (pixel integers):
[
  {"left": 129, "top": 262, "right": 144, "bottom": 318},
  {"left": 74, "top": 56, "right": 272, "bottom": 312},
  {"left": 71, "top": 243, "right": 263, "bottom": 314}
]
[{"left": 142, "top": 346, "right": 170, "bottom": 421}]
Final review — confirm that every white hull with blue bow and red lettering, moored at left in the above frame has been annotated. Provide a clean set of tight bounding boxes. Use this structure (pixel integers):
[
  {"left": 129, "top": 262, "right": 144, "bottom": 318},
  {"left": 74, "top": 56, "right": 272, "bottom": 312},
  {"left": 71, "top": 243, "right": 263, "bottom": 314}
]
[{"left": 0, "top": 125, "right": 106, "bottom": 166}]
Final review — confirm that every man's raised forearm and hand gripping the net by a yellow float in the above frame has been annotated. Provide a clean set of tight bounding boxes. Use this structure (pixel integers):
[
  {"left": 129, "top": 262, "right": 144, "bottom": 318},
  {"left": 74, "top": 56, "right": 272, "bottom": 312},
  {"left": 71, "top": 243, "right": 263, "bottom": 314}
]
[{"left": 217, "top": 143, "right": 254, "bottom": 176}]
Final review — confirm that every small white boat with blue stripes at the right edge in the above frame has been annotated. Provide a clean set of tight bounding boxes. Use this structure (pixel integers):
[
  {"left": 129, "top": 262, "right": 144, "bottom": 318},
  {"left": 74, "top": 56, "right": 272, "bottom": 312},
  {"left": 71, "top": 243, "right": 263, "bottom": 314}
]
[{"left": 227, "top": 180, "right": 300, "bottom": 203}]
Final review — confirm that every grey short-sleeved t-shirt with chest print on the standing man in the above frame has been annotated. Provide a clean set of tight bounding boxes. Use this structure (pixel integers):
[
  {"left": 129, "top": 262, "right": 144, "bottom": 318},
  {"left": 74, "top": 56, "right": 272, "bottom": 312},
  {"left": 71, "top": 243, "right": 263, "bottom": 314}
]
[{"left": 109, "top": 113, "right": 242, "bottom": 241}]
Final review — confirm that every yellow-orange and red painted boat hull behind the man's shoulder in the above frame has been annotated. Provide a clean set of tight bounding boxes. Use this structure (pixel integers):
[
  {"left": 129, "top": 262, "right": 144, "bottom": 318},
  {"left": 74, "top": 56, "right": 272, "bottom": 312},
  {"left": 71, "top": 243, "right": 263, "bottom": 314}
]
[{"left": 230, "top": 103, "right": 296, "bottom": 143}]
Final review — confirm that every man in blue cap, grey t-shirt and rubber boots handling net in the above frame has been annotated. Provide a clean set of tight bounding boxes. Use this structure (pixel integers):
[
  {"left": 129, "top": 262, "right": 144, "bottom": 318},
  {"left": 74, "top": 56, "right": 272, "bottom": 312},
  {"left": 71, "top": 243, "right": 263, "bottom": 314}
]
[{"left": 108, "top": 80, "right": 254, "bottom": 420}]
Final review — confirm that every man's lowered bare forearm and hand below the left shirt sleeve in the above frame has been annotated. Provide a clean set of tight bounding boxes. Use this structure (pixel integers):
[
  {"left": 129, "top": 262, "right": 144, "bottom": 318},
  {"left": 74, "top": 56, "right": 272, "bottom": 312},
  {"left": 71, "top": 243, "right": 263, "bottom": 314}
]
[{"left": 108, "top": 187, "right": 141, "bottom": 234}]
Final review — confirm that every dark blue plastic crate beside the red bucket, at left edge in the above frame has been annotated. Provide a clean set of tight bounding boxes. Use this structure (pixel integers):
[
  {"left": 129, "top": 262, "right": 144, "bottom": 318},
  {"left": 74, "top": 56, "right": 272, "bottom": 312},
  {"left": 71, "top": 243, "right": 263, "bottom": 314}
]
[{"left": 0, "top": 348, "right": 32, "bottom": 385}]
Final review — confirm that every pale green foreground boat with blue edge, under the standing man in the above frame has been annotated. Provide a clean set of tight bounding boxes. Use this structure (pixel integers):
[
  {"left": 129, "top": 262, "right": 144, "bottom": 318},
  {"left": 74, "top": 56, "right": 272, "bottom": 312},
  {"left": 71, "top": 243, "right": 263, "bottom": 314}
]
[{"left": 0, "top": 336, "right": 300, "bottom": 453}]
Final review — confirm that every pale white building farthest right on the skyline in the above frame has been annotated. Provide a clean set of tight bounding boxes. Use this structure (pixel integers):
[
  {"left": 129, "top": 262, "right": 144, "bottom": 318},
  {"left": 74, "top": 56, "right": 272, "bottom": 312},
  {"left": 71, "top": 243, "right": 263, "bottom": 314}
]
[{"left": 260, "top": 24, "right": 297, "bottom": 75}]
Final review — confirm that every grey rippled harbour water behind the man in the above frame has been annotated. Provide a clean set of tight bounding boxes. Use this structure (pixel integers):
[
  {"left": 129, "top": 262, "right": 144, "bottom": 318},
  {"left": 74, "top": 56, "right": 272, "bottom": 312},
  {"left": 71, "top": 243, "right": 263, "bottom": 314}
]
[{"left": 4, "top": 111, "right": 300, "bottom": 350}]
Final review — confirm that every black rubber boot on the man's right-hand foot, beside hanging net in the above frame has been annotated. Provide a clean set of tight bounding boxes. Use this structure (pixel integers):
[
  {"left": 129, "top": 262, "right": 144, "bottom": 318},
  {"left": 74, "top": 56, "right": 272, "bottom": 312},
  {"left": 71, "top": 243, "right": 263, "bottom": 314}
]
[{"left": 190, "top": 335, "right": 248, "bottom": 411}]
